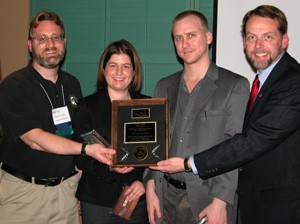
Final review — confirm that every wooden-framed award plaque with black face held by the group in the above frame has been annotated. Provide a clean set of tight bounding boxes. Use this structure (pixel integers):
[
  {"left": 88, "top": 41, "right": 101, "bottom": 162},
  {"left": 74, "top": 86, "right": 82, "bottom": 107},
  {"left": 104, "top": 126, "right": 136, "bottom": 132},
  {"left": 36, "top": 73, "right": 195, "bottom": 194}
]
[{"left": 111, "top": 98, "right": 168, "bottom": 166}]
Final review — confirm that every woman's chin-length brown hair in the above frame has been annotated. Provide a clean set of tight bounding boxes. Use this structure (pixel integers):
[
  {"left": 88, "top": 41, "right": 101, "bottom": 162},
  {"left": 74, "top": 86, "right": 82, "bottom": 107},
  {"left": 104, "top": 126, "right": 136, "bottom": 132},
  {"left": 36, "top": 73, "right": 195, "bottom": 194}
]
[{"left": 96, "top": 40, "right": 142, "bottom": 92}]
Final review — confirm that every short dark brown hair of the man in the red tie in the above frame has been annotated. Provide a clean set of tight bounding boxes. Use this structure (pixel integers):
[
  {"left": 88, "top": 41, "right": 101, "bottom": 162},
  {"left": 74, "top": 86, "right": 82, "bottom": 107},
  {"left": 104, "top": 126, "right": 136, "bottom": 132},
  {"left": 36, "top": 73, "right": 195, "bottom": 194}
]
[{"left": 241, "top": 5, "right": 288, "bottom": 37}]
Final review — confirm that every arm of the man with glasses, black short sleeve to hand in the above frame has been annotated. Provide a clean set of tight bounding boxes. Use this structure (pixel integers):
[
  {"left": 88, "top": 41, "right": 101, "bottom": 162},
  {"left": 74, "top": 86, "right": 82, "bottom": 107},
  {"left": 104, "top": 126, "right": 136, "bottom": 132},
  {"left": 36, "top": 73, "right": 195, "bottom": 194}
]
[{"left": 0, "top": 80, "right": 114, "bottom": 164}]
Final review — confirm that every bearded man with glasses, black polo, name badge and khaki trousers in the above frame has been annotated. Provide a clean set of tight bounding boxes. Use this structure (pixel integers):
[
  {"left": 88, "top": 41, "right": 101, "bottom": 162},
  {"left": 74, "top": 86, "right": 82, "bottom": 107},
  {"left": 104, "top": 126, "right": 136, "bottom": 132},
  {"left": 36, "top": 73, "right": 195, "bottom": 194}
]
[{"left": 0, "top": 12, "right": 114, "bottom": 224}]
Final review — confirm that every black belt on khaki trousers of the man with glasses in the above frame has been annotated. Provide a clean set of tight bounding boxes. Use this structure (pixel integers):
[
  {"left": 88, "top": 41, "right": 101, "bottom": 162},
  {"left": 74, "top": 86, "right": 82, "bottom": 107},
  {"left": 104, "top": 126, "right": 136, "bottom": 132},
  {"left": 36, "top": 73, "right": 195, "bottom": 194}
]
[{"left": 1, "top": 163, "right": 78, "bottom": 187}]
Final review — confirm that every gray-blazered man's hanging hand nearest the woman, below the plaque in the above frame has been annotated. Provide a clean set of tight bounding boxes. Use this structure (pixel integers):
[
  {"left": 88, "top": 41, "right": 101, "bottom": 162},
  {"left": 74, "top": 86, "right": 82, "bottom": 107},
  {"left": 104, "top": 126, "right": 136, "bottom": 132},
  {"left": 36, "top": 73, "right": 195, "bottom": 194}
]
[{"left": 146, "top": 179, "right": 161, "bottom": 224}]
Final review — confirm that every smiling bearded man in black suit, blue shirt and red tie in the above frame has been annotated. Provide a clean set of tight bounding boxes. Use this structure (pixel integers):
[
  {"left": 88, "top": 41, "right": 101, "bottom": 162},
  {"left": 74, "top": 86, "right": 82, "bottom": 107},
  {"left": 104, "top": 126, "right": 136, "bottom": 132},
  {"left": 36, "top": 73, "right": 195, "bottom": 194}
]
[{"left": 153, "top": 5, "right": 300, "bottom": 224}]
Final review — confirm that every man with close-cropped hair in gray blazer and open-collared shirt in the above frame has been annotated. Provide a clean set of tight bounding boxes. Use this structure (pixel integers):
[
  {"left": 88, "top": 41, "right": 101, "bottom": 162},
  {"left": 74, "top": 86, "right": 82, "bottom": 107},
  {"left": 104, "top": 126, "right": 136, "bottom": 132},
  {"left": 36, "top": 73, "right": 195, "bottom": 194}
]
[{"left": 146, "top": 11, "right": 249, "bottom": 224}]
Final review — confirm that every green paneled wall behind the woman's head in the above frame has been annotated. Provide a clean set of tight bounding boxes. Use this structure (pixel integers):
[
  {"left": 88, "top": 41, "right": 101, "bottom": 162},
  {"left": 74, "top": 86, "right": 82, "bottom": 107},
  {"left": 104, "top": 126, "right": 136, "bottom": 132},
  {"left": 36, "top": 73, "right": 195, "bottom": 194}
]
[{"left": 31, "top": 0, "right": 214, "bottom": 96}]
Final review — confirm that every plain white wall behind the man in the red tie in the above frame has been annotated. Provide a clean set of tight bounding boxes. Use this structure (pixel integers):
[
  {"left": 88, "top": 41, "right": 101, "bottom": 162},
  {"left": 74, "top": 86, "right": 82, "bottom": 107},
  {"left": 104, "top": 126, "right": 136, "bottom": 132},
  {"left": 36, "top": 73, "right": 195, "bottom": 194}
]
[{"left": 216, "top": 0, "right": 300, "bottom": 83}]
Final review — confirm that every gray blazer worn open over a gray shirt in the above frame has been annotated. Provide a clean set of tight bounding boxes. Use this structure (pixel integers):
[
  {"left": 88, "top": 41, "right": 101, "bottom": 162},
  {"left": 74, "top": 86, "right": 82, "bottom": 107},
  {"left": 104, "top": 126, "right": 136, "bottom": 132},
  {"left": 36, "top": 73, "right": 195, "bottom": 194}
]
[{"left": 150, "top": 62, "right": 249, "bottom": 223}]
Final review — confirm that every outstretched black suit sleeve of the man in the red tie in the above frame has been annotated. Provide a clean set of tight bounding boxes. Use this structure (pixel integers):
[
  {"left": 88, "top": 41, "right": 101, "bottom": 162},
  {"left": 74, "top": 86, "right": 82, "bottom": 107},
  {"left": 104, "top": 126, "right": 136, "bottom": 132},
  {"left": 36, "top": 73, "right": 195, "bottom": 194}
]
[{"left": 194, "top": 73, "right": 300, "bottom": 179}]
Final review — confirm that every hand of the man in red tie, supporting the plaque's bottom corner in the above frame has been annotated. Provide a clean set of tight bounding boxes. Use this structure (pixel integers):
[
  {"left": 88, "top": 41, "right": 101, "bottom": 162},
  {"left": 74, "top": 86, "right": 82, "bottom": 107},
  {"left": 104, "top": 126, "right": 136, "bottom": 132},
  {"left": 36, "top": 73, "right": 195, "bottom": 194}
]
[{"left": 149, "top": 157, "right": 184, "bottom": 173}]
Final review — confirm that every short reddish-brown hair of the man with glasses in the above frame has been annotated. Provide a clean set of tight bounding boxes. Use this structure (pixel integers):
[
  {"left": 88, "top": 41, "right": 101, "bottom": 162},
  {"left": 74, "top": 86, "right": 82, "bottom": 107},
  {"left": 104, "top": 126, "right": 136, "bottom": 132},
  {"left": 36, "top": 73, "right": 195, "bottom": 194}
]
[{"left": 28, "top": 11, "right": 65, "bottom": 40}]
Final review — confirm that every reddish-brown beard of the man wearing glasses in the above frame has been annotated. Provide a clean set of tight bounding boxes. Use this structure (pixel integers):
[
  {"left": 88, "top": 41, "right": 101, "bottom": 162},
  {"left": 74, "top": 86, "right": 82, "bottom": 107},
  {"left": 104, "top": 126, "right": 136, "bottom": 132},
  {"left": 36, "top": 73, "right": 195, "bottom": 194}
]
[{"left": 32, "top": 47, "right": 65, "bottom": 69}]
